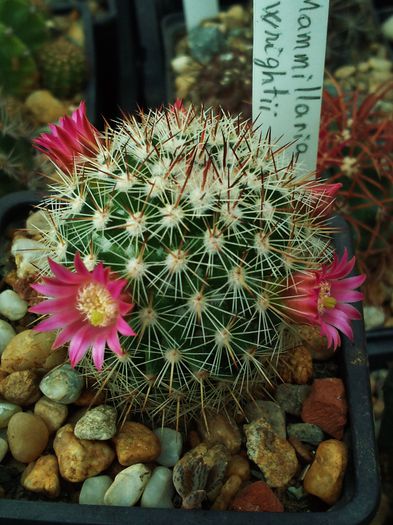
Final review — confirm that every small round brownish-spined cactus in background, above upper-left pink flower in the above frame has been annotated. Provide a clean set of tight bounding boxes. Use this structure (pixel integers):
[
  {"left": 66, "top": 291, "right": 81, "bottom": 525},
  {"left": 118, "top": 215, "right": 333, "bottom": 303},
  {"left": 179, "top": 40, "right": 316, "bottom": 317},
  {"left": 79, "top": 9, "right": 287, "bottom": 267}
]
[{"left": 38, "top": 37, "right": 87, "bottom": 98}]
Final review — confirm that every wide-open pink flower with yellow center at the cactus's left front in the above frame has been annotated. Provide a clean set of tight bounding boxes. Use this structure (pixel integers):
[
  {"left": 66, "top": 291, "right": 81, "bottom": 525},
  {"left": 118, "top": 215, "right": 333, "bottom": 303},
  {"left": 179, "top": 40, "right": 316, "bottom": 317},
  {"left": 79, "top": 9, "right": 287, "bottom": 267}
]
[{"left": 29, "top": 253, "right": 135, "bottom": 370}]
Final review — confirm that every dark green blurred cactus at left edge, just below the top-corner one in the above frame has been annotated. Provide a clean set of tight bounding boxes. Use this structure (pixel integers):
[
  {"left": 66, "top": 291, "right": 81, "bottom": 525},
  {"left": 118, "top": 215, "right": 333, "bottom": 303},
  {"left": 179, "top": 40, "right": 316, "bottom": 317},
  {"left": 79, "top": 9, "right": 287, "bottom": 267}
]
[{"left": 0, "top": 22, "right": 38, "bottom": 97}]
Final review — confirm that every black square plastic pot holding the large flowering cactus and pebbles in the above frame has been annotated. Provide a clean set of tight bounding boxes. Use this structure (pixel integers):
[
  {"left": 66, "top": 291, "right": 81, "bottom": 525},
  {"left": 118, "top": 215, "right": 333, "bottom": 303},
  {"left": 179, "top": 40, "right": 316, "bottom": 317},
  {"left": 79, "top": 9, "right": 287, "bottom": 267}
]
[{"left": 0, "top": 192, "right": 379, "bottom": 525}]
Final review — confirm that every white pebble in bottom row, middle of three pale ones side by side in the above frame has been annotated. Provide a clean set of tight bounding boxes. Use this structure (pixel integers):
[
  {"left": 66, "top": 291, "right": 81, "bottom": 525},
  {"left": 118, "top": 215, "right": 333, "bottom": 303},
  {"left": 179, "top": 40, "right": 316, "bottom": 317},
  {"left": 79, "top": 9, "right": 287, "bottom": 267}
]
[{"left": 104, "top": 463, "right": 151, "bottom": 507}]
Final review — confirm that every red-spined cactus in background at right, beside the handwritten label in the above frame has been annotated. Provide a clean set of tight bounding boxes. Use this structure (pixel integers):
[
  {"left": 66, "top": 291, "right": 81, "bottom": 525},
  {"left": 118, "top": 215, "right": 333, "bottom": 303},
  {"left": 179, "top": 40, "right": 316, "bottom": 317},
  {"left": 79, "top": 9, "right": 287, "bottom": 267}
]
[{"left": 318, "top": 82, "right": 393, "bottom": 283}]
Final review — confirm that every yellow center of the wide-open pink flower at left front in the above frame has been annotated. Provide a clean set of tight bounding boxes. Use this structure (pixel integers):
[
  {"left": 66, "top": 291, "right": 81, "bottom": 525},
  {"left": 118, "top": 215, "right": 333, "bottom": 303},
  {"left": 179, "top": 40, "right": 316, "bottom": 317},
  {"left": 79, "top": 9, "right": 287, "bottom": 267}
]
[{"left": 76, "top": 283, "right": 118, "bottom": 327}]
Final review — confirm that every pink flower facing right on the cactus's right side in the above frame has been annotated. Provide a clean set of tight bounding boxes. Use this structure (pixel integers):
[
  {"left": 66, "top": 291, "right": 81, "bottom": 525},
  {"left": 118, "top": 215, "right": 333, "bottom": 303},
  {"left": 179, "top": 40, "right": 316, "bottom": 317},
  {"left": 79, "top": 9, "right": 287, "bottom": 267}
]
[{"left": 284, "top": 249, "right": 366, "bottom": 350}]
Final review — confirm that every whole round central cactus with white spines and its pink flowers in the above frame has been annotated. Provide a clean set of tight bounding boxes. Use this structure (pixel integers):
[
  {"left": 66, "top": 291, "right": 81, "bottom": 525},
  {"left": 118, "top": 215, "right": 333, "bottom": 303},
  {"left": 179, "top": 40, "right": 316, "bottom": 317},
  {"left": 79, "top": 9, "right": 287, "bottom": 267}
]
[{"left": 32, "top": 102, "right": 362, "bottom": 421}]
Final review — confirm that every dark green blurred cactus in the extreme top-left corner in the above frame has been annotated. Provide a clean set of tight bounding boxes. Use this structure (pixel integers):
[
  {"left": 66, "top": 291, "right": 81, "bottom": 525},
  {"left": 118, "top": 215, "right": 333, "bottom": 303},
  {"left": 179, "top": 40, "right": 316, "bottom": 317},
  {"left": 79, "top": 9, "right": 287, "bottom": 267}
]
[{"left": 0, "top": 0, "right": 49, "bottom": 52}]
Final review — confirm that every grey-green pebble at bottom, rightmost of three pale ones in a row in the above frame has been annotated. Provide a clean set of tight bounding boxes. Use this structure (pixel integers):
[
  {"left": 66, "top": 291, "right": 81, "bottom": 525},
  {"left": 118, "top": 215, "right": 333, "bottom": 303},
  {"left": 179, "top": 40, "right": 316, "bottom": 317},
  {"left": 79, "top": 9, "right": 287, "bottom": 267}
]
[{"left": 141, "top": 467, "right": 174, "bottom": 509}]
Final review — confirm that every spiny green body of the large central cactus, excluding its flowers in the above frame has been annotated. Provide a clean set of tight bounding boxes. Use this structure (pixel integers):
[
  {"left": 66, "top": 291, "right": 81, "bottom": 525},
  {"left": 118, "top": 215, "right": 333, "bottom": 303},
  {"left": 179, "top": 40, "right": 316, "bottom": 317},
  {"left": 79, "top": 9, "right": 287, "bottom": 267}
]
[{"left": 36, "top": 104, "right": 332, "bottom": 420}]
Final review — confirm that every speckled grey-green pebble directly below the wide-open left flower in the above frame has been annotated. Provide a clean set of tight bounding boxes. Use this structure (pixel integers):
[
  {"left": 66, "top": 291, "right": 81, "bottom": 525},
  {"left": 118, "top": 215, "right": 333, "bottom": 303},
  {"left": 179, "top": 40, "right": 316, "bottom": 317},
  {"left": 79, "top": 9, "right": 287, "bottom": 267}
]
[{"left": 40, "top": 363, "right": 84, "bottom": 405}]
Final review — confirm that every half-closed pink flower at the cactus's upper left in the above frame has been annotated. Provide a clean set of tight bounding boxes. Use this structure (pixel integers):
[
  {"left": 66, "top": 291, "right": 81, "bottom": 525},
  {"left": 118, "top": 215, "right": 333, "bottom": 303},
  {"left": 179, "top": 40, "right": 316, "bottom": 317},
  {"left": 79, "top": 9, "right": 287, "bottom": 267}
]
[{"left": 33, "top": 101, "right": 99, "bottom": 171}]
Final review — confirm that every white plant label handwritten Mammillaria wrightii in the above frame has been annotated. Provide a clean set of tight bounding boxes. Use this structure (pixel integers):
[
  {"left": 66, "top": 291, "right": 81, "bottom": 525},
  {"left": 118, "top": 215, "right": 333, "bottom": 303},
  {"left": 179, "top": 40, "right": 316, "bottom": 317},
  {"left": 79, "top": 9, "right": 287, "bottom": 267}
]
[{"left": 252, "top": 0, "right": 329, "bottom": 176}]
